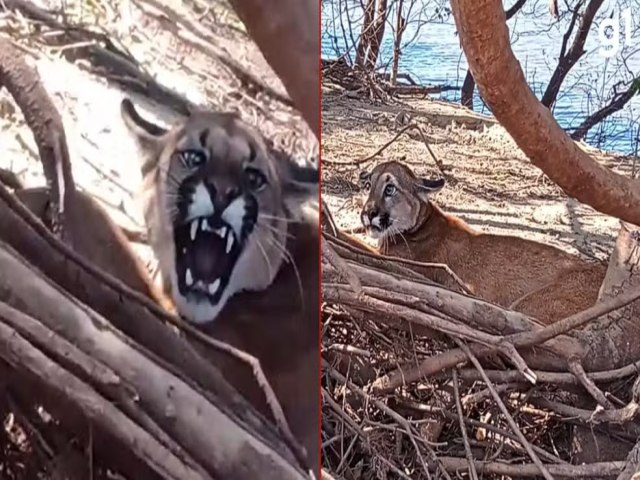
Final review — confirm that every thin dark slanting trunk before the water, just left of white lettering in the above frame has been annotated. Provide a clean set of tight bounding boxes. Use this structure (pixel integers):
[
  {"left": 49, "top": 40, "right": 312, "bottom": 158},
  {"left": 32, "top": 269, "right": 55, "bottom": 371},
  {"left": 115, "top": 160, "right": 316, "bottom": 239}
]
[{"left": 542, "top": 0, "right": 604, "bottom": 108}]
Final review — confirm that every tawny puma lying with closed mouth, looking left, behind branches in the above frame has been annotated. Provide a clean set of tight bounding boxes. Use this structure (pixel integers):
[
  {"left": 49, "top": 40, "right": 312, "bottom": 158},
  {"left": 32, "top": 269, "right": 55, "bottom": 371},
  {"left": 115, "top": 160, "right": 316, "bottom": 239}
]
[{"left": 360, "top": 161, "right": 606, "bottom": 323}]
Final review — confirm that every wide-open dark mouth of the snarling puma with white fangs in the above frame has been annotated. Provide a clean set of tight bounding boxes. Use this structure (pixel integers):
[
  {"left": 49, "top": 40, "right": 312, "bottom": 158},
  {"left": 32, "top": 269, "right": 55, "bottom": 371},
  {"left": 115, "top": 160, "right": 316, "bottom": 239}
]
[{"left": 173, "top": 216, "right": 243, "bottom": 304}]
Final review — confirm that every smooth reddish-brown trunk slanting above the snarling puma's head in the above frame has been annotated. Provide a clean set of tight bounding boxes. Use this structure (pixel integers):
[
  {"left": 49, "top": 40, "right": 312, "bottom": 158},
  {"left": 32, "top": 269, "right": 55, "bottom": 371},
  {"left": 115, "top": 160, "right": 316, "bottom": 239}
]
[{"left": 226, "top": 0, "right": 320, "bottom": 138}]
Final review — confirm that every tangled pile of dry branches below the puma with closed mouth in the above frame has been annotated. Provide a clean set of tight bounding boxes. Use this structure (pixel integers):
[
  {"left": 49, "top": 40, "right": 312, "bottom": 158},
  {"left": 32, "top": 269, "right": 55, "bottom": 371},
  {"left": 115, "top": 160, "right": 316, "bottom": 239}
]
[{"left": 322, "top": 215, "right": 640, "bottom": 480}]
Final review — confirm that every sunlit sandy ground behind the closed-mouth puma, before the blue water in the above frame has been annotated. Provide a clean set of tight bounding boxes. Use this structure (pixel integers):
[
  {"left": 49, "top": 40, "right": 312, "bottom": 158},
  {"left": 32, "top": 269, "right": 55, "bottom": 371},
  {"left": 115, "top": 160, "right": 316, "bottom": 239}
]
[{"left": 322, "top": 83, "right": 632, "bottom": 258}]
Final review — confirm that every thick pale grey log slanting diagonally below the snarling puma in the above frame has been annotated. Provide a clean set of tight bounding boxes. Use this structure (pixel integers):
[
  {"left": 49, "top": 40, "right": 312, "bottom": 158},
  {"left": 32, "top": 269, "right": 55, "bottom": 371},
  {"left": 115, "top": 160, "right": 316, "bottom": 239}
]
[{"left": 0, "top": 240, "right": 304, "bottom": 479}]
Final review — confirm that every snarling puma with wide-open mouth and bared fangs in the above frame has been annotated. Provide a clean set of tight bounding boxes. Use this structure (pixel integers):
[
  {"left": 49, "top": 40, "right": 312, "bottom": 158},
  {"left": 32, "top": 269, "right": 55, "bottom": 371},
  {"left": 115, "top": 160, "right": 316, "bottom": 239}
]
[{"left": 121, "top": 100, "right": 320, "bottom": 478}]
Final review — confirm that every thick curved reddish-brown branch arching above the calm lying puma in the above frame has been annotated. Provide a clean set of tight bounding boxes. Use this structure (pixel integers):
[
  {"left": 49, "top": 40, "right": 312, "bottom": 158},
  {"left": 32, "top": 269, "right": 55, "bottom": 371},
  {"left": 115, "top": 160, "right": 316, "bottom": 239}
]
[{"left": 451, "top": 0, "right": 640, "bottom": 225}]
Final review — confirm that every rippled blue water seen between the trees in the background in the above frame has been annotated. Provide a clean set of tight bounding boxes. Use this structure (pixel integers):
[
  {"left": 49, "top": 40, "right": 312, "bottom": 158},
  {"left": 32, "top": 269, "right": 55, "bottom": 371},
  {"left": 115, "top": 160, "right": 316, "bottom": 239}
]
[{"left": 322, "top": 0, "right": 640, "bottom": 154}]
